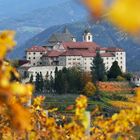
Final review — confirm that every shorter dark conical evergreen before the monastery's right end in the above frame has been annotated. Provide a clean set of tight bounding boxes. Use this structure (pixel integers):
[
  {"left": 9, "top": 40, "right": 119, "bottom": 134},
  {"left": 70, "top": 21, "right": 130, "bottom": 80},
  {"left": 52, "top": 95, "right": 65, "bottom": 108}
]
[{"left": 108, "top": 61, "right": 122, "bottom": 79}]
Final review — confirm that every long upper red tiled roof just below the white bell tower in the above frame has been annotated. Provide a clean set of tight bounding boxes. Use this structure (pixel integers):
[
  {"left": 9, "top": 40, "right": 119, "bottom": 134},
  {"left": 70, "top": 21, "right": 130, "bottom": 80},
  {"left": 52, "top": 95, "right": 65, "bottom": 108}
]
[{"left": 62, "top": 42, "right": 100, "bottom": 50}]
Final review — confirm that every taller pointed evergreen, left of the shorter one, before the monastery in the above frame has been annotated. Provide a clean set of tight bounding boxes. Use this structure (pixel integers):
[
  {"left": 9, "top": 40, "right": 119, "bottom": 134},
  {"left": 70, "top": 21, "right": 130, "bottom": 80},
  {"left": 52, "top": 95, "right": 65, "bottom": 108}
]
[{"left": 91, "top": 53, "right": 106, "bottom": 82}]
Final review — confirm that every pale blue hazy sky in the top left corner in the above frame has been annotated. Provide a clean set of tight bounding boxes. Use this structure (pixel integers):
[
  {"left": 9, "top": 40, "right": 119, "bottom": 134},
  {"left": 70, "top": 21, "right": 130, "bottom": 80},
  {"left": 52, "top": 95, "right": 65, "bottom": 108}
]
[{"left": 0, "top": 0, "right": 68, "bottom": 16}]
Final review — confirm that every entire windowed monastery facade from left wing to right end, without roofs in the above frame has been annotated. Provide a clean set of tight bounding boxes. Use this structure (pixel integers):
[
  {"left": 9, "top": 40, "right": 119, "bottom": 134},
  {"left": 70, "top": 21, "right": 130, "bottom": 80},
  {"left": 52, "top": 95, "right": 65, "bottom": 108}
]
[{"left": 27, "top": 51, "right": 126, "bottom": 72}]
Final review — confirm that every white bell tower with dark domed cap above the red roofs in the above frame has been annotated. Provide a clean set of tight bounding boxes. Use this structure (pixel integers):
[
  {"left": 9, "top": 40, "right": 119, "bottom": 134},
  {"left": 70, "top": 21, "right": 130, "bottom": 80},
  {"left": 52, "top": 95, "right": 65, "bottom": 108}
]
[{"left": 83, "top": 29, "right": 93, "bottom": 42}]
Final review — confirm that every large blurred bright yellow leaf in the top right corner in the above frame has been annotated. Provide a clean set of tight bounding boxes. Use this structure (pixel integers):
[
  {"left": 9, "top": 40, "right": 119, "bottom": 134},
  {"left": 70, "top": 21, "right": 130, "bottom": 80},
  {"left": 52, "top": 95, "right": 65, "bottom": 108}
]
[{"left": 109, "top": 0, "right": 140, "bottom": 33}]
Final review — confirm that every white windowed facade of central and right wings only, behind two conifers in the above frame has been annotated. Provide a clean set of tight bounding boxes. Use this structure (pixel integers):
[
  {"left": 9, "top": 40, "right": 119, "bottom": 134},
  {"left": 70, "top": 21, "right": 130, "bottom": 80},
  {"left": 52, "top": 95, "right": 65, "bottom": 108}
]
[{"left": 59, "top": 52, "right": 126, "bottom": 72}]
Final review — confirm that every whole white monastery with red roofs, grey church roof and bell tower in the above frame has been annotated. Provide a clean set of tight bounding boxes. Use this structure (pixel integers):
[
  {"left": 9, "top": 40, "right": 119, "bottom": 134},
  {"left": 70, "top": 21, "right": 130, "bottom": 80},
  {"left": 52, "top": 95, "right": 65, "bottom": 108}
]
[{"left": 21, "top": 28, "right": 126, "bottom": 80}]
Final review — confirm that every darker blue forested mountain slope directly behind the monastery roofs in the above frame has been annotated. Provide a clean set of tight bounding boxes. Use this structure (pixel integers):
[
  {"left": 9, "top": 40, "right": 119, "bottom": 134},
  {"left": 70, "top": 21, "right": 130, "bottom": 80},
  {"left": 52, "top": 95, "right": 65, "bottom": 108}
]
[{"left": 10, "top": 21, "right": 140, "bottom": 71}]
